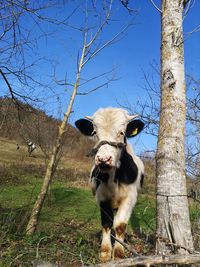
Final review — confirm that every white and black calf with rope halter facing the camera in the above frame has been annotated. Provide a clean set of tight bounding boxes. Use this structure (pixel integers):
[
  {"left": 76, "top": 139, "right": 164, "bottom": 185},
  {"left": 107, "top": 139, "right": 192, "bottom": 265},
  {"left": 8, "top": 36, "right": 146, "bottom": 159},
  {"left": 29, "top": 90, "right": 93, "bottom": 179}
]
[{"left": 75, "top": 108, "right": 144, "bottom": 262}]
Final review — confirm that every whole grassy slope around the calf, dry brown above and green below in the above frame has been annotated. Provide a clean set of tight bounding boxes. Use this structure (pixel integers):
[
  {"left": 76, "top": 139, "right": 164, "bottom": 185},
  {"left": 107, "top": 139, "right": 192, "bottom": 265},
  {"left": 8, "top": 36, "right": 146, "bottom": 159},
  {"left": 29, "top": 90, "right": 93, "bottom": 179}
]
[{"left": 0, "top": 138, "right": 155, "bottom": 266}]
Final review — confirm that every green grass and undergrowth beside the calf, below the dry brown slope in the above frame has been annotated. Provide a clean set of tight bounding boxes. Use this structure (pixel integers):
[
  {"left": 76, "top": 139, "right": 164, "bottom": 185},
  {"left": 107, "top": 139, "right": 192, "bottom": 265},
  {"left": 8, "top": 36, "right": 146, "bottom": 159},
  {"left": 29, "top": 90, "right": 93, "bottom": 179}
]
[{"left": 0, "top": 176, "right": 153, "bottom": 266}]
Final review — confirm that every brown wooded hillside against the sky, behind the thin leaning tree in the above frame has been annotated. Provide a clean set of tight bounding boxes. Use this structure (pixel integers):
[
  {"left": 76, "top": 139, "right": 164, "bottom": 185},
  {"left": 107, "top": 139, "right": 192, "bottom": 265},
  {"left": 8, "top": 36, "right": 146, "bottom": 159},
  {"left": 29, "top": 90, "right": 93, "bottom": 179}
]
[{"left": 0, "top": 98, "right": 91, "bottom": 157}]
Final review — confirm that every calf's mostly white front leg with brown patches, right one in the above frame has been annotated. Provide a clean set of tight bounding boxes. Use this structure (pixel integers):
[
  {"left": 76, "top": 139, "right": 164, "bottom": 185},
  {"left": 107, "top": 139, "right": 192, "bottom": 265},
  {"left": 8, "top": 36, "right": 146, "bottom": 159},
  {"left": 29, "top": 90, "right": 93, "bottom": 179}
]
[{"left": 113, "top": 194, "right": 136, "bottom": 259}]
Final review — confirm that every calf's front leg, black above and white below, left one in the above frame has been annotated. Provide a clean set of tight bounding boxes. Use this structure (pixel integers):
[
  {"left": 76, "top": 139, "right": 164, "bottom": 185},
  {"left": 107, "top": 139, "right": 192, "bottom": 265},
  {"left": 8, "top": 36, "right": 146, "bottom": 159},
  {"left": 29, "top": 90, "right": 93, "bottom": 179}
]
[{"left": 100, "top": 201, "right": 113, "bottom": 262}]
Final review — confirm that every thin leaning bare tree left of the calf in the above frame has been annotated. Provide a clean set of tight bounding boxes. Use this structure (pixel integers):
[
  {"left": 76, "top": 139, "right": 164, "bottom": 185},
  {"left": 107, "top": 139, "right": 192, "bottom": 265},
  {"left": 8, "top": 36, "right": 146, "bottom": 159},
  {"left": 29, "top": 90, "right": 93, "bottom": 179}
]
[{"left": 26, "top": 0, "right": 130, "bottom": 235}]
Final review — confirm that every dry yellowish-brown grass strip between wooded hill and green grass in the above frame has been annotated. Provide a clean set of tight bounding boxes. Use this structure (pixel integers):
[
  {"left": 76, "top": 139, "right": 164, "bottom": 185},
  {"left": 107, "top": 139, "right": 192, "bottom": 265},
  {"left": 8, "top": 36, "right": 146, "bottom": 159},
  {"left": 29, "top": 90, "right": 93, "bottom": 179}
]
[{"left": 0, "top": 138, "right": 92, "bottom": 192}]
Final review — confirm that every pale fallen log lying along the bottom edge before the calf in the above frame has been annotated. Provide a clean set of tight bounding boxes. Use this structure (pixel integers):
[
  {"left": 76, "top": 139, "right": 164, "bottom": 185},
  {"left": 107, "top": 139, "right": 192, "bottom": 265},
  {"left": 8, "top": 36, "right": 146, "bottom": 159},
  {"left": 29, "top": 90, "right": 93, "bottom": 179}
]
[{"left": 90, "top": 254, "right": 200, "bottom": 267}]
